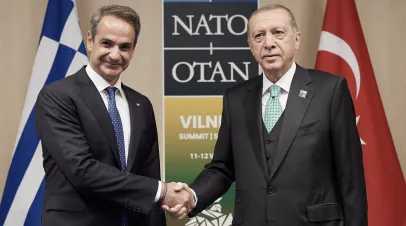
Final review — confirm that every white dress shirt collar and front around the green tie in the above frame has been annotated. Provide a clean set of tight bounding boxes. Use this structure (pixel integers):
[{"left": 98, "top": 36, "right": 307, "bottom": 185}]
[{"left": 262, "top": 62, "right": 296, "bottom": 119}]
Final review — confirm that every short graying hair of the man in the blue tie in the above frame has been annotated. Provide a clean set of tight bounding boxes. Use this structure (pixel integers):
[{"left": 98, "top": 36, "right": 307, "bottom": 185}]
[{"left": 90, "top": 5, "right": 141, "bottom": 44}]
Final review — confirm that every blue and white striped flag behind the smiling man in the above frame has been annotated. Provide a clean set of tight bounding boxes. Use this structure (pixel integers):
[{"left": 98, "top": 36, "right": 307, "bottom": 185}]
[{"left": 0, "top": 0, "right": 88, "bottom": 226}]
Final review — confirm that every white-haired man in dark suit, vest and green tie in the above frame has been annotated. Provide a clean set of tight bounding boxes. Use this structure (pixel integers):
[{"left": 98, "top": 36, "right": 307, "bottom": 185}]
[{"left": 164, "top": 5, "right": 367, "bottom": 226}]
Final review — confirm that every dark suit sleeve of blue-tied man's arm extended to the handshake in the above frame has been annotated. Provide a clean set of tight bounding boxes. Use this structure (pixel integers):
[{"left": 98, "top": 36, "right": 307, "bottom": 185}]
[{"left": 36, "top": 86, "right": 159, "bottom": 214}]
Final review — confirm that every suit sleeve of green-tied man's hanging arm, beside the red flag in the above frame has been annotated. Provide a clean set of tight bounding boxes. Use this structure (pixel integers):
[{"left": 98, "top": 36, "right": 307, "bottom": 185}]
[{"left": 331, "top": 77, "right": 368, "bottom": 226}]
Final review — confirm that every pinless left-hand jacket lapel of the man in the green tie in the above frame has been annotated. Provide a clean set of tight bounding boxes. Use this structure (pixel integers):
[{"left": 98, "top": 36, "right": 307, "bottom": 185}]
[{"left": 244, "top": 76, "right": 269, "bottom": 180}]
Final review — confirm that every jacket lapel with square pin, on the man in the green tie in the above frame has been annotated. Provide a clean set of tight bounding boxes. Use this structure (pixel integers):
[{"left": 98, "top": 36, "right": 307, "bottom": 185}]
[{"left": 270, "top": 65, "right": 314, "bottom": 178}]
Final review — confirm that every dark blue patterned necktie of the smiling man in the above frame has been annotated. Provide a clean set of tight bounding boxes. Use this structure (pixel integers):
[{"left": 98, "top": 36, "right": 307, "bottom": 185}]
[{"left": 106, "top": 87, "right": 128, "bottom": 226}]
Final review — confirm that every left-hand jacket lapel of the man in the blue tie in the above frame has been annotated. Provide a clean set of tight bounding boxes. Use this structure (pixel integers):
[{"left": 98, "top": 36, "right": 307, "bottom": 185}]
[{"left": 78, "top": 68, "right": 120, "bottom": 166}]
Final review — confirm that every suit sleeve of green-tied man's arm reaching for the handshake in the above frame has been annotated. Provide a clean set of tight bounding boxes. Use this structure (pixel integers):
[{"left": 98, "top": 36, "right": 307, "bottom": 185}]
[{"left": 189, "top": 88, "right": 235, "bottom": 217}]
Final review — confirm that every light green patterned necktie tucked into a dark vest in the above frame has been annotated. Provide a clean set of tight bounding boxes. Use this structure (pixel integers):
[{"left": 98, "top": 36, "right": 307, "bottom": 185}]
[{"left": 264, "top": 85, "right": 282, "bottom": 133}]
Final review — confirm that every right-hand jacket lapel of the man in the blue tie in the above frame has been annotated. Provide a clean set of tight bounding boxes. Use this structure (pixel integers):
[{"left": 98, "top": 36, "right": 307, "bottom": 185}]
[{"left": 122, "top": 85, "right": 146, "bottom": 171}]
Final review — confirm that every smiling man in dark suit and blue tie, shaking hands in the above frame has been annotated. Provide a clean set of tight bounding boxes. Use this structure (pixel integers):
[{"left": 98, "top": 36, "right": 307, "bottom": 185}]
[{"left": 36, "top": 5, "right": 193, "bottom": 226}]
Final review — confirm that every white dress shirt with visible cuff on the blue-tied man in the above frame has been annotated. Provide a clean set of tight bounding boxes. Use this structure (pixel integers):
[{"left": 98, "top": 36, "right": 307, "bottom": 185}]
[{"left": 86, "top": 64, "right": 161, "bottom": 202}]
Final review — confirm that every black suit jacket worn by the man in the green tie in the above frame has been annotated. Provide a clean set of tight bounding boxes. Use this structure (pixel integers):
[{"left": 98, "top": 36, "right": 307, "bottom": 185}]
[{"left": 190, "top": 66, "right": 367, "bottom": 226}]
